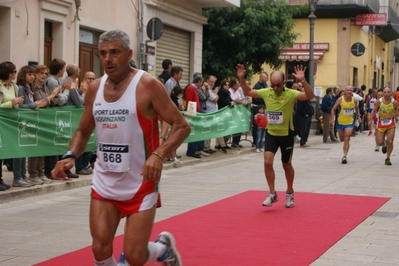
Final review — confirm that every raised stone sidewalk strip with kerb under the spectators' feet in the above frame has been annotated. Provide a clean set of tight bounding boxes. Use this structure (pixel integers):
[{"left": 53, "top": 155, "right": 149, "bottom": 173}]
[{"left": 0, "top": 135, "right": 255, "bottom": 204}]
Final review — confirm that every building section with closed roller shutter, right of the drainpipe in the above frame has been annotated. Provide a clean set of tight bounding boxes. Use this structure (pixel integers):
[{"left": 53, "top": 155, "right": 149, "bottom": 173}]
[{"left": 145, "top": 0, "right": 240, "bottom": 86}]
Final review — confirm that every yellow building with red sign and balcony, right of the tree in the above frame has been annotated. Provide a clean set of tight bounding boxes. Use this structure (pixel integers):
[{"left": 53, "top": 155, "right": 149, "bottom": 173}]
[{"left": 258, "top": 0, "right": 399, "bottom": 93}]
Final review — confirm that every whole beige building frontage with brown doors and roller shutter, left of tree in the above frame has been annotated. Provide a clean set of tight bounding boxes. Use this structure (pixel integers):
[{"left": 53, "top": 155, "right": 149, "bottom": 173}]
[{"left": 0, "top": 0, "right": 240, "bottom": 85}]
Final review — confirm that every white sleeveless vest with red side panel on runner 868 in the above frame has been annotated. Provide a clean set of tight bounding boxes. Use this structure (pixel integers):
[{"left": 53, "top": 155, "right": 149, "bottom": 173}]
[{"left": 92, "top": 70, "right": 159, "bottom": 203}]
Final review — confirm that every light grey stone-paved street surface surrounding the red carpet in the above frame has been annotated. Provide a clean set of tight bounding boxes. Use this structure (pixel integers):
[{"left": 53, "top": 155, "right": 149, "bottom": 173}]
[{"left": 0, "top": 128, "right": 399, "bottom": 266}]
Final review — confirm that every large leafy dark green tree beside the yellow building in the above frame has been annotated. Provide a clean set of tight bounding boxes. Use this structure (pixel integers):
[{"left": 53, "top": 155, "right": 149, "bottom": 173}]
[{"left": 202, "top": 0, "right": 308, "bottom": 80}]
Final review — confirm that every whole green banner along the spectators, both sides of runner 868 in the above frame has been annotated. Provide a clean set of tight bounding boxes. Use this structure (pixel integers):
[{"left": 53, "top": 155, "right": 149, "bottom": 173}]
[{"left": 0, "top": 105, "right": 251, "bottom": 159}]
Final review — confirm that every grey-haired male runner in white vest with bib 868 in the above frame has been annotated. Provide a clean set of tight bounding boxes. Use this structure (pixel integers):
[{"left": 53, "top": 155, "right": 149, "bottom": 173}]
[{"left": 52, "top": 30, "right": 190, "bottom": 266}]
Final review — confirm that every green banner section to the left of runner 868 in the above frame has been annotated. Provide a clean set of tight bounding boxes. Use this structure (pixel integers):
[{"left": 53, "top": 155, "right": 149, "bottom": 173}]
[{"left": 0, "top": 106, "right": 96, "bottom": 159}]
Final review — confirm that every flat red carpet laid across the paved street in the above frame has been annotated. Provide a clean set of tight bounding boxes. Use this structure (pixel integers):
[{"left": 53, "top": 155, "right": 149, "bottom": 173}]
[{"left": 36, "top": 191, "right": 389, "bottom": 266}]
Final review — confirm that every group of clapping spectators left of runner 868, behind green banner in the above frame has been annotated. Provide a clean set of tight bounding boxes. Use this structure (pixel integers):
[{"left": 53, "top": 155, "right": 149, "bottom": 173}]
[{"left": 0, "top": 58, "right": 95, "bottom": 191}]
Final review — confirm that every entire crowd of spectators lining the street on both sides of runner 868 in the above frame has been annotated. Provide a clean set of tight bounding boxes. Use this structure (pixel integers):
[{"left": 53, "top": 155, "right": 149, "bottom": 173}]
[{"left": 0, "top": 58, "right": 399, "bottom": 191}]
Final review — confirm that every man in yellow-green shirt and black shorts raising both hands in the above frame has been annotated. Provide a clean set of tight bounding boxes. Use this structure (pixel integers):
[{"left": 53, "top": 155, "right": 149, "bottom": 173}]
[{"left": 236, "top": 64, "right": 314, "bottom": 208}]
